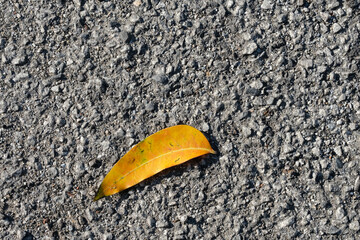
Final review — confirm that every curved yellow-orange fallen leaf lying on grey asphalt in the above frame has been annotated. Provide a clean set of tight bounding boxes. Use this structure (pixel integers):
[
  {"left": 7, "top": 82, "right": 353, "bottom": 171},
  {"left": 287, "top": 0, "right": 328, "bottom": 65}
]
[{"left": 94, "top": 125, "right": 215, "bottom": 201}]
